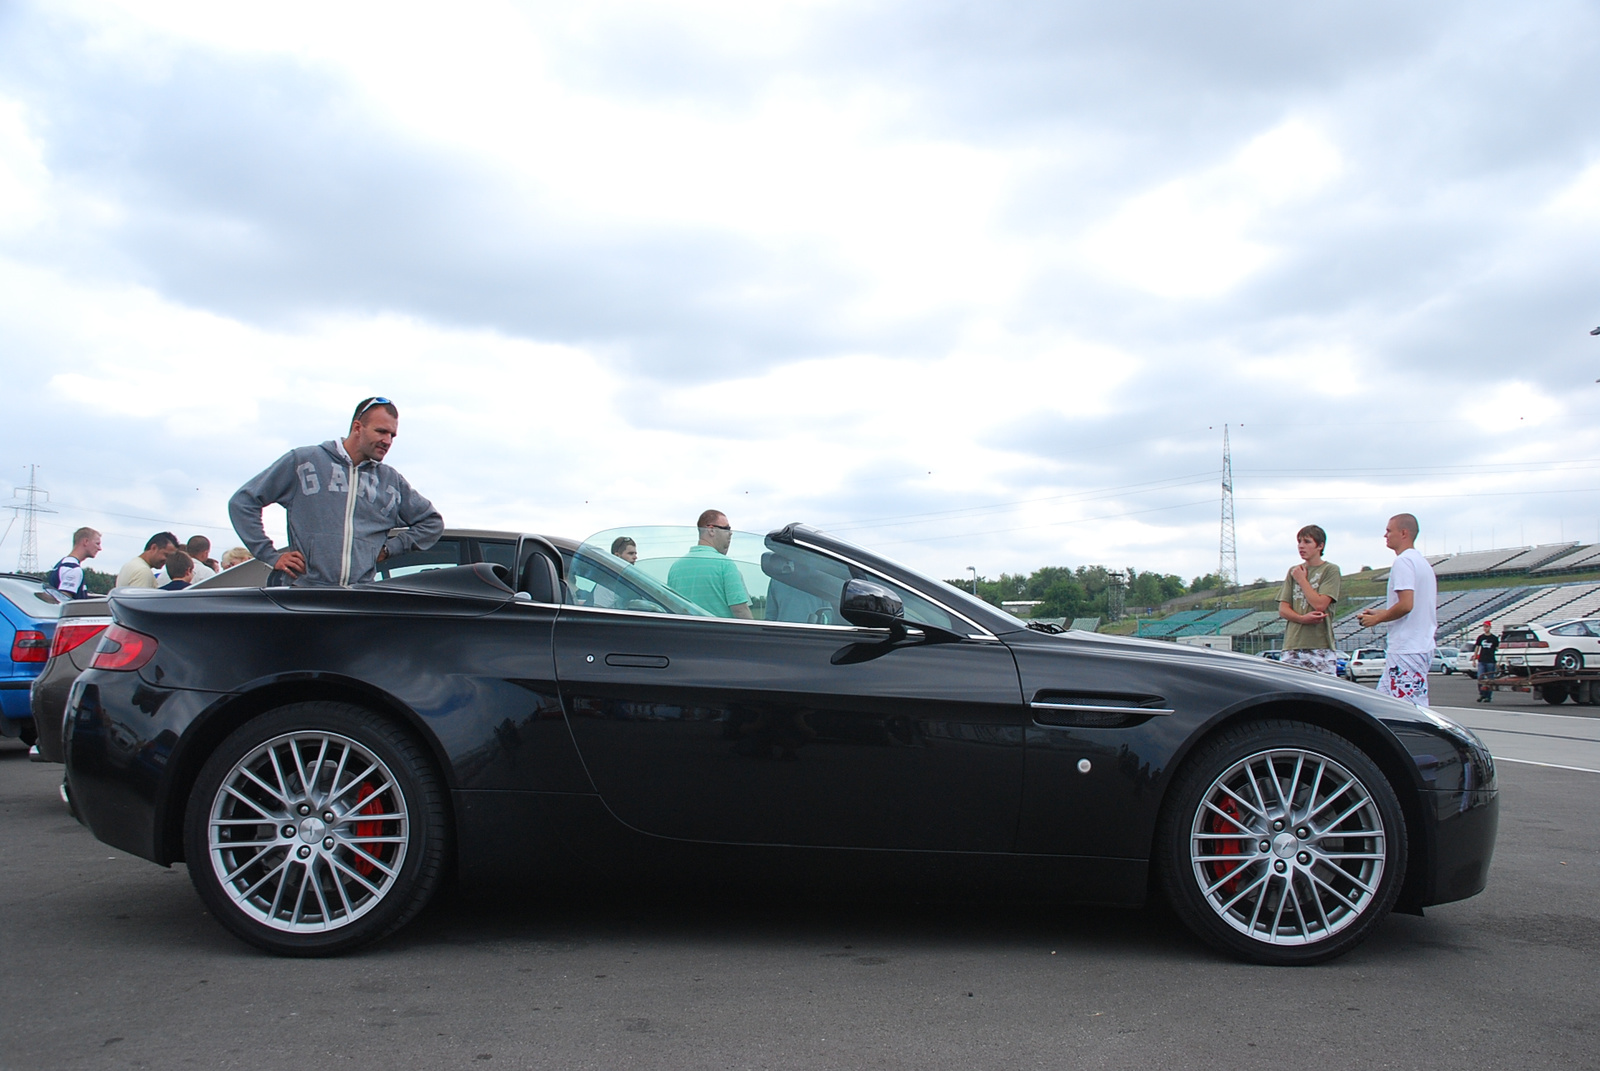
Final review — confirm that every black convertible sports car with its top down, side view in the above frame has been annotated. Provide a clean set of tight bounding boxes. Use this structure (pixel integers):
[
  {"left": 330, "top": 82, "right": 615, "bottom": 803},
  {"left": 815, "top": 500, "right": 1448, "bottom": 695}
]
[{"left": 66, "top": 523, "right": 1499, "bottom": 964}]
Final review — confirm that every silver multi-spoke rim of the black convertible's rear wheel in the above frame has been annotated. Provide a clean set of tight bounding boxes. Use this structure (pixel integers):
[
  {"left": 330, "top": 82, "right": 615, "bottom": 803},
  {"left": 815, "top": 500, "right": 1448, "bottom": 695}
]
[{"left": 206, "top": 732, "right": 411, "bottom": 933}]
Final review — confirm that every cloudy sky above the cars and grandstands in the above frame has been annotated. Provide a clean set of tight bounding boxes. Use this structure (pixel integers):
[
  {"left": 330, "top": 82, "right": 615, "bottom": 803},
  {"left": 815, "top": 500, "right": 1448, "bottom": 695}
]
[{"left": 0, "top": 0, "right": 1600, "bottom": 580}]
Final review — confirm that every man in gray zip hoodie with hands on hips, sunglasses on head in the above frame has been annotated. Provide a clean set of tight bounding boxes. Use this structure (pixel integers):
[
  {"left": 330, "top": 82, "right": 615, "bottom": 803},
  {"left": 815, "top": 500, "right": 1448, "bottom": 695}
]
[{"left": 227, "top": 397, "right": 445, "bottom": 588}]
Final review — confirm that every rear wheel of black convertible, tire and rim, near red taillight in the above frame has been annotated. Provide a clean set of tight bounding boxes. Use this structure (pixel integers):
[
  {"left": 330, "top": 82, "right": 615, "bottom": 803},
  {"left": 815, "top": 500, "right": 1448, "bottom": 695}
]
[{"left": 184, "top": 703, "right": 450, "bottom": 956}]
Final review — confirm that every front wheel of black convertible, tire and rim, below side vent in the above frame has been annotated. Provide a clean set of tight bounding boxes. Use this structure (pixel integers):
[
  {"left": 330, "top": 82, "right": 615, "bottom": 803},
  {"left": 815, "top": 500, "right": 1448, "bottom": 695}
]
[{"left": 1155, "top": 720, "right": 1406, "bottom": 967}]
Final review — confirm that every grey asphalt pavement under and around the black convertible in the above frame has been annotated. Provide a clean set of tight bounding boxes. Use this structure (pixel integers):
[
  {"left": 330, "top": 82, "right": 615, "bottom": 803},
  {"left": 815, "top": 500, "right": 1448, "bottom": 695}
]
[{"left": 0, "top": 694, "right": 1600, "bottom": 1071}]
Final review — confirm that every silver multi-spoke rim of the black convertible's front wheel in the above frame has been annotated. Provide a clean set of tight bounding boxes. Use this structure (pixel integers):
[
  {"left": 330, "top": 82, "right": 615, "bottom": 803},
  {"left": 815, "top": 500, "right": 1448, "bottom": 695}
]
[{"left": 1189, "top": 748, "right": 1387, "bottom": 945}]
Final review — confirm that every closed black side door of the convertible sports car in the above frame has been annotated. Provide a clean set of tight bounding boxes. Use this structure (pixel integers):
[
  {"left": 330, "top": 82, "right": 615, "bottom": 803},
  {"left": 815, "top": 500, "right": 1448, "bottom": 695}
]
[{"left": 555, "top": 536, "right": 1027, "bottom": 852}]
